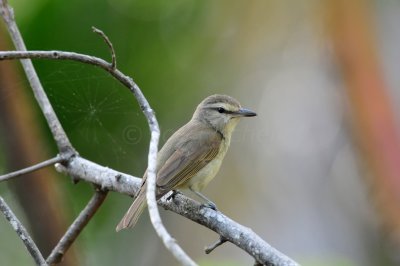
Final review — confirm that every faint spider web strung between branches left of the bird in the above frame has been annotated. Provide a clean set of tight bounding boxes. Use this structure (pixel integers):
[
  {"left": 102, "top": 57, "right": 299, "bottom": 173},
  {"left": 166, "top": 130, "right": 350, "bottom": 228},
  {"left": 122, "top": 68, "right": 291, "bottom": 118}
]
[{"left": 41, "top": 62, "right": 146, "bottom": 168}]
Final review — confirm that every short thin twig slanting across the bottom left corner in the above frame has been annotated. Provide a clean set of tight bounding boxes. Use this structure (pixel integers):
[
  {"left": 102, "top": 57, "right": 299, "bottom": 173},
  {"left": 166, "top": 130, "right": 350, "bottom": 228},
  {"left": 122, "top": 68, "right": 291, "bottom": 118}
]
[{"left": 0, "top": 196, "right": 47, "bottom": 265}]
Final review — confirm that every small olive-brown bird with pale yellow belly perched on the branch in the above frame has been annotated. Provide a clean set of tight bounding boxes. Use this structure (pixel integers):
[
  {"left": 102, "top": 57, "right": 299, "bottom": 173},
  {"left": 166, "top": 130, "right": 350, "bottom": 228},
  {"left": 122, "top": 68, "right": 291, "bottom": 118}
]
[{"left": 116, "top": 95, "right": 257, "bottom": 232}]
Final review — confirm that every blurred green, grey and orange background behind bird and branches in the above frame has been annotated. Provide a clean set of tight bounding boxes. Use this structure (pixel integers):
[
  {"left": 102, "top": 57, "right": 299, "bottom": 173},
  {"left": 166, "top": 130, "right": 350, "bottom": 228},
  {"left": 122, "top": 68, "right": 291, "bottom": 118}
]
[{"left": 0, "top": 0, "right": 400, "bottom": 266}]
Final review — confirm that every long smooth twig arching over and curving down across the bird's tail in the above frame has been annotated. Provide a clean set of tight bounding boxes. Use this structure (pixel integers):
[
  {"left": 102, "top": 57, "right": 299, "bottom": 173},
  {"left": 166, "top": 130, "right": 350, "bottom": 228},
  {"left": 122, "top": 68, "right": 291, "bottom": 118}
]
[{"left": 0, "top": 51, "right": 196, "bottom": 265}]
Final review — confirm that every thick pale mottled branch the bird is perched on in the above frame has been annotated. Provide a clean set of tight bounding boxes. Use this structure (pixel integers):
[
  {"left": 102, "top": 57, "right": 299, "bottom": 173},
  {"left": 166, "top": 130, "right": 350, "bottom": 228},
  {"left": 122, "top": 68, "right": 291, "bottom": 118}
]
[{"left": 56, "top": 156, "right": 298, "bottom": 266}]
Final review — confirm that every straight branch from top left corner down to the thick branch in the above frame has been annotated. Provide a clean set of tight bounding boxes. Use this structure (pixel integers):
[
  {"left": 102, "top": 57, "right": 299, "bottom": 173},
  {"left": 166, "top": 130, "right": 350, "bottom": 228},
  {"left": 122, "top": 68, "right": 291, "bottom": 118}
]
[{"left": 0, "top": 0, "right": 75, "bottom": 153}]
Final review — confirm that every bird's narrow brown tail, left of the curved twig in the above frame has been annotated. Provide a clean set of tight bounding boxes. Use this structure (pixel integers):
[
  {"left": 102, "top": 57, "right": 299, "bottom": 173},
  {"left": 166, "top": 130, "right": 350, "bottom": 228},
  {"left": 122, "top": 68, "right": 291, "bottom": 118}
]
[{"left": 115, "top": 187, "right": 147, "bottom": 232}]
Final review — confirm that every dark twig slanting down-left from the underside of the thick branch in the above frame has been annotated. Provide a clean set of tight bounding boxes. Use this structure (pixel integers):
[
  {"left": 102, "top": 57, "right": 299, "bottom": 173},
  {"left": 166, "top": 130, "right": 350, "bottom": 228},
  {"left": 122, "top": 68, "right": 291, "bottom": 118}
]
[{"left": 46, "top": 190, "right": 107, "bottom": 265}]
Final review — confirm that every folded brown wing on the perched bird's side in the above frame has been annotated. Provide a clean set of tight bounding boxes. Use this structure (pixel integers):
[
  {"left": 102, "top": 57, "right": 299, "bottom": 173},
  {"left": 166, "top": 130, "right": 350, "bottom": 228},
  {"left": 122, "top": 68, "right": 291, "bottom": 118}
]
[{"left": 157, "top": 130, "right": 221, "bottom": 194}]
